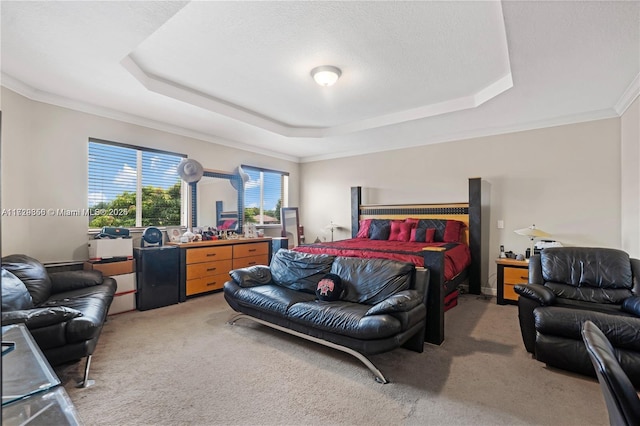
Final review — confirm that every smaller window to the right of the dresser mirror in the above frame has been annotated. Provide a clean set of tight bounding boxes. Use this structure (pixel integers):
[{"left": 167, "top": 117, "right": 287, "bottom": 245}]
[{"left": 242, "top": 165, "right": 289, "bottom": 225}]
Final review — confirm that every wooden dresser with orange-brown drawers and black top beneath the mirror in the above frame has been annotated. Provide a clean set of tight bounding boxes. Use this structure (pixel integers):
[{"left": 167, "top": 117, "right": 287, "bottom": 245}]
[{"left": 168, "top": 238, "right": 271, "bottom": 301}]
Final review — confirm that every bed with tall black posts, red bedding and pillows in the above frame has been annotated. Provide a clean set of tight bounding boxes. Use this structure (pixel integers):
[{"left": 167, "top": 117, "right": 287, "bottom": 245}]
[{"left": 294, "top": 178, "right": 483, "bottom": 345}]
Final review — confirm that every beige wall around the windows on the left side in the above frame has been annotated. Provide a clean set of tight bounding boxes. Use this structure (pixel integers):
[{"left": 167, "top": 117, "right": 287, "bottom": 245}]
[{"left": 1, "top": 88, "right": 299, "bottom": 262}]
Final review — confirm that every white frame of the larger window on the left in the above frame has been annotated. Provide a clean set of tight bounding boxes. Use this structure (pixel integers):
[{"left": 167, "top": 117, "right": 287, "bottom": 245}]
[{"left": 86, "top": 137, "right": 189, "bottom": 233}]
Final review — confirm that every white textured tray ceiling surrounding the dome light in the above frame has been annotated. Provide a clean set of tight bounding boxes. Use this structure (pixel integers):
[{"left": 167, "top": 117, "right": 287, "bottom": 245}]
[{"left": 0, "top": 1, "right": 640, "bottom": 161}]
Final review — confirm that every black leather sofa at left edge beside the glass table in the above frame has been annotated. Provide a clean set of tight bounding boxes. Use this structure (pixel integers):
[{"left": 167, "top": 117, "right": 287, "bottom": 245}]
[{"left": 2, "top": 254, "right": 117, "bottom": 387}]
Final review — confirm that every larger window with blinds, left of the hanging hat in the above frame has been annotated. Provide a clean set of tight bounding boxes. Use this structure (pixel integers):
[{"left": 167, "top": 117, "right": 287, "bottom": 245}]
[{"left": 87, "top": 139, "right": 186, "bottom": 228}]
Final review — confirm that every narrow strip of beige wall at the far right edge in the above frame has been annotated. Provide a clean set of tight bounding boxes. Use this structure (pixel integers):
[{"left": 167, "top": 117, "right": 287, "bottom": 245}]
[{"left": 620, "top": 97, "right": 640, "bottom": 258}]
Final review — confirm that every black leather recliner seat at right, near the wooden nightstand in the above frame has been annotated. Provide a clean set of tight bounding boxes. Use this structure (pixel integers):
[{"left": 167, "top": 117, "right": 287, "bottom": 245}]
[{"left": 515, "top": 247, "right": 640, "bottom": 386}]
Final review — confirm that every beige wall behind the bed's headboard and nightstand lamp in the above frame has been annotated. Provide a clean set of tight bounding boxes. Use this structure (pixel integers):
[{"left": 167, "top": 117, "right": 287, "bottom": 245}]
[{"left": 300, "top": 119, "right": 621, "bottom": 291}]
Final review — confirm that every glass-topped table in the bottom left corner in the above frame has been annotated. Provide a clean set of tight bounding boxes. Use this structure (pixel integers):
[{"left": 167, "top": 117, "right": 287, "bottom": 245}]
[{"left": 2, "top": 324, "right": 81, "bottom": 426}]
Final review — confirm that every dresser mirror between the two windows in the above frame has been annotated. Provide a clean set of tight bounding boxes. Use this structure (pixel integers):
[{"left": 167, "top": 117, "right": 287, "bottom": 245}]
[{"left": 189, "top": 170, "right": 244, "bottom": 232}]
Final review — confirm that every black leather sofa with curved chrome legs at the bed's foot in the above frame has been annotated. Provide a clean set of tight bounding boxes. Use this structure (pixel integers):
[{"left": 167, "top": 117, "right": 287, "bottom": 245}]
[{"left": 224, "top": 249, "right": 429, "bottom": 383}]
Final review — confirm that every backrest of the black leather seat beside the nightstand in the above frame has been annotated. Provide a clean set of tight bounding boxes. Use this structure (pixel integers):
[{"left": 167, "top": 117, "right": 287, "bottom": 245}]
[{"left": 529, "top": 247, "right": 638, "bottom": 304}]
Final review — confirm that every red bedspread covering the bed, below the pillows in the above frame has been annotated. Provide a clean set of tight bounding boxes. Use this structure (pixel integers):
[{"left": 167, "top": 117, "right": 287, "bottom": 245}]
[{"left": 294, "top": 238, "right": 471, "bottom": 281}]
